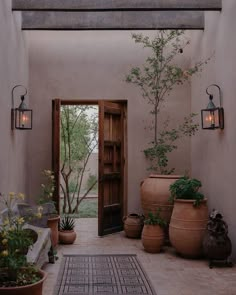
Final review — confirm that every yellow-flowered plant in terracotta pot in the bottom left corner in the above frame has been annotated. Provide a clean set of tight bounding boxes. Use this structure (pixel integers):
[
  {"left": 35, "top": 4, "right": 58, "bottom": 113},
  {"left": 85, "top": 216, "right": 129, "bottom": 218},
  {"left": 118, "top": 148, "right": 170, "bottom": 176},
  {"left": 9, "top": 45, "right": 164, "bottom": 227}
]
[{"left": 0, "top": 193, "right": 46, "bottom": 295}]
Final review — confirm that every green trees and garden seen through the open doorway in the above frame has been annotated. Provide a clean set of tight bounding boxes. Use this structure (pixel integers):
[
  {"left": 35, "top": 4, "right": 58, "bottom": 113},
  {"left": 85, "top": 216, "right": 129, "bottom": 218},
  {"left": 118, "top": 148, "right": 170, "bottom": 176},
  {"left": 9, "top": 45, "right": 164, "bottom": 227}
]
[{"left": 60, "top": 105, "right": 98, "bottom": 215}]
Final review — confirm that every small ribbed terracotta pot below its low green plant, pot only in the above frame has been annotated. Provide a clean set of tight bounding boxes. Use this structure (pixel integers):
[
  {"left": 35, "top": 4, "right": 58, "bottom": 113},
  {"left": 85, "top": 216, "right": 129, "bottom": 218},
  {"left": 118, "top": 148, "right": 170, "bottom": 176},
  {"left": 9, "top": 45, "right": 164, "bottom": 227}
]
[{"left": 142, "top": 224, "right": 165, "bottom": 253}]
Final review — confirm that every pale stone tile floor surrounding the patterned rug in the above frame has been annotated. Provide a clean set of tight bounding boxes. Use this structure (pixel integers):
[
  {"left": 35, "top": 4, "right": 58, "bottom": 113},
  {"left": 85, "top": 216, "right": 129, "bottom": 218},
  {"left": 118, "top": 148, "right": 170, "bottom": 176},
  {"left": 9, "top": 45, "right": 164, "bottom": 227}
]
[{"left": 43, "top": 218, "right": 236, "bottom": 295}]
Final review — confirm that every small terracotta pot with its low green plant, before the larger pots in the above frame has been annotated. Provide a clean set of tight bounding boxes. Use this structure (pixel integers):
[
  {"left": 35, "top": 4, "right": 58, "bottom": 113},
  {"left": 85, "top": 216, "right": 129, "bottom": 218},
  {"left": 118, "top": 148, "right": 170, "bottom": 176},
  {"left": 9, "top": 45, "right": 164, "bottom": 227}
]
[{"left": 142, "top": 209, "right": 166, "bottom": 253}]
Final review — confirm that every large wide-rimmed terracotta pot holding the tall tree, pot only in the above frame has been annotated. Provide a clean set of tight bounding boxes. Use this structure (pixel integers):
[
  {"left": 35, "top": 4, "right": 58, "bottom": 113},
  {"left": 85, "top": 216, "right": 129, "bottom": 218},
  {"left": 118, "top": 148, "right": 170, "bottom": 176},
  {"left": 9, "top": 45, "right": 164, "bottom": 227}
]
[{"left": 141, "top": 174, "right": 181, "bottom": 223}]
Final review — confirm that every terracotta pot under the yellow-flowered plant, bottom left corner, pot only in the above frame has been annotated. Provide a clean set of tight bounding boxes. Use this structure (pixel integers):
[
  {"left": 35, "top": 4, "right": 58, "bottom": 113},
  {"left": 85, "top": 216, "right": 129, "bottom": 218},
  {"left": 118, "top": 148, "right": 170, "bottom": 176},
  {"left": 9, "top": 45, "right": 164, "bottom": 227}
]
[{"left": 0, "top": 270, "right": 47, "bottom": 295}]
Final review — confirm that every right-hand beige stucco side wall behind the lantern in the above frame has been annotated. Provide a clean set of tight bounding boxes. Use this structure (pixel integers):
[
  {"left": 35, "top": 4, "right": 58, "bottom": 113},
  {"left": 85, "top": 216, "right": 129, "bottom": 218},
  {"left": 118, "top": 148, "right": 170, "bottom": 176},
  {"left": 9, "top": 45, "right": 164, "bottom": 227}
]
[{"left": 191, "top": 0, "right": 236, "bottom": 257}]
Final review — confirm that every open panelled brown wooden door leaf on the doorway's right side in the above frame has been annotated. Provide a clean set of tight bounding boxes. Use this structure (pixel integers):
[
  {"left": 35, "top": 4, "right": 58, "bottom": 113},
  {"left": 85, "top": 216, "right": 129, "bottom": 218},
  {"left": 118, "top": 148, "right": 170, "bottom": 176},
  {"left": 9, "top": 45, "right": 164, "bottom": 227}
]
[{"left": 98, "top": 101, "right": 126, "bottom": 236}]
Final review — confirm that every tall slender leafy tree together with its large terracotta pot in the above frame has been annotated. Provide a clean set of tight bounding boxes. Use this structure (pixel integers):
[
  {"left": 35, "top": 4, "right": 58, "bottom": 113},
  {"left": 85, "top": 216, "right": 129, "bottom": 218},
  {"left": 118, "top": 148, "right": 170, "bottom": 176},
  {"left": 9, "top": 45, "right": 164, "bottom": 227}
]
[{"left": 126, "top": 30, "right": 207, "bottom": 222}]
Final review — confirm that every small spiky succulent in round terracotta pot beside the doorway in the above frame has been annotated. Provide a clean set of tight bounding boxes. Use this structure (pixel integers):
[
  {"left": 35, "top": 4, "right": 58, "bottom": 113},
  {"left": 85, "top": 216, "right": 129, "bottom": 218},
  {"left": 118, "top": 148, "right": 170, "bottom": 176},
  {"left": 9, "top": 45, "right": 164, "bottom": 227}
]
[{"left": 59, "top": 215, "right": 76, "bottom": 244}]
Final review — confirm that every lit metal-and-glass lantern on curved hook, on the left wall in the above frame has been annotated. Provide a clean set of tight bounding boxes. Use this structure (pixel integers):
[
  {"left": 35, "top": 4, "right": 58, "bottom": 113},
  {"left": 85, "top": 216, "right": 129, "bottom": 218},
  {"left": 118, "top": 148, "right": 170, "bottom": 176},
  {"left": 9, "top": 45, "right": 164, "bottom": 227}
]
[{"left": 11, "top": 85, "right": 33, "bottom": 130}]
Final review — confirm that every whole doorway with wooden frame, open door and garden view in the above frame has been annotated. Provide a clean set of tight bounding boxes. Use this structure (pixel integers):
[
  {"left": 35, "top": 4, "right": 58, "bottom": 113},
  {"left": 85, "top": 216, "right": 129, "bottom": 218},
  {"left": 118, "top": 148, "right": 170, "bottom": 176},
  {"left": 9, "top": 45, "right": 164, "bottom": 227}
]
[{"left": 52, "top": 99, "right": 127, "bottom": 236}]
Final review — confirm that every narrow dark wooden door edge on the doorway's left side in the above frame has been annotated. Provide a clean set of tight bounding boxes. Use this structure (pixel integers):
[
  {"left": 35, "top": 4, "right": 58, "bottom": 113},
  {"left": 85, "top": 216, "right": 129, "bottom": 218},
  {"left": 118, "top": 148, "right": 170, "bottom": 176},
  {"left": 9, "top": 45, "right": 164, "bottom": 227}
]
[{"left": 52, "top": 99, "right": 61, "bottom": 214}]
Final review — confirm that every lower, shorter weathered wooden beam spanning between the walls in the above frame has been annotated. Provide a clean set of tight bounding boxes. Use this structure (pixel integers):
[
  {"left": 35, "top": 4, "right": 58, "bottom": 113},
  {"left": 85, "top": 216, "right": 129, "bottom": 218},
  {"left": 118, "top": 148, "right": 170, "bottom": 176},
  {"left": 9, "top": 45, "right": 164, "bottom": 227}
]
[{"left": 22, "top": 11, "right": 204, "bottom": 30}]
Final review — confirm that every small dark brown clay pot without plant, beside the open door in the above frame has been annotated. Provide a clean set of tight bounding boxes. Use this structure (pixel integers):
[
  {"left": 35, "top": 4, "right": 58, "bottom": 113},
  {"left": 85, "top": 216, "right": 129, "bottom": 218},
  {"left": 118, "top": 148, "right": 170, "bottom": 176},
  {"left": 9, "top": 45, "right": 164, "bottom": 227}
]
[{"left": 123, "top": 213, "right": 144, "bottom": 239}]
